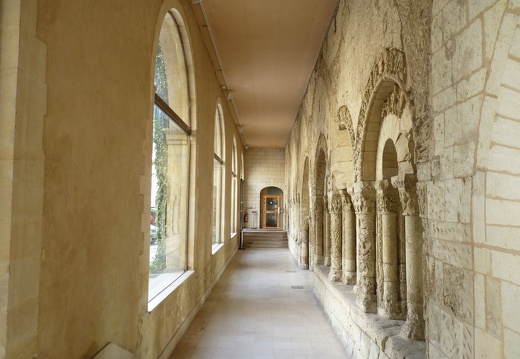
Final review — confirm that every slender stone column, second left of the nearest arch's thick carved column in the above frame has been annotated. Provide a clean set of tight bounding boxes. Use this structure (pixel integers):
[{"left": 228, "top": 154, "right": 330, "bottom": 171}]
[{"left": 329, "top": 195, "right": 342, "bottom": 282}]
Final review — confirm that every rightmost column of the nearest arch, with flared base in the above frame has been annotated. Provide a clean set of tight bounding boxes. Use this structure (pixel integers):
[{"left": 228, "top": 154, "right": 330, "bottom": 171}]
[{"left": 392, "top": 175, "right": 424, "bottom": 339}]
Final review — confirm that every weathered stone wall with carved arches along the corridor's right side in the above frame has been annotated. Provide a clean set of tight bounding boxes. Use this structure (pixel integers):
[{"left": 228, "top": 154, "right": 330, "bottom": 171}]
[{"left": 286, "top": 0, "right": 520, "bottom": 358}]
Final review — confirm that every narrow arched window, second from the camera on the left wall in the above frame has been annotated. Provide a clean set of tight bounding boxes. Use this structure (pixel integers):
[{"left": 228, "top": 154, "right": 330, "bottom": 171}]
[{"left": 212, "top": 104, "right": 224, "bottom": 250}]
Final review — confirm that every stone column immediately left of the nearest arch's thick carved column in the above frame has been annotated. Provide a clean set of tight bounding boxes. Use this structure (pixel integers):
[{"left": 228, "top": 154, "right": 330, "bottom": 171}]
[{"left": 341, "top": 191, "right": 356, "bottom": 284}]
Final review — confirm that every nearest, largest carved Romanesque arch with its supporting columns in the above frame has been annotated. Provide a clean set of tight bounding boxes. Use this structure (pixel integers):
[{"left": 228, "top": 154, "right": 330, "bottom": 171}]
[{"left": 353, "top": 48, "right": 424, "bottom": 339}]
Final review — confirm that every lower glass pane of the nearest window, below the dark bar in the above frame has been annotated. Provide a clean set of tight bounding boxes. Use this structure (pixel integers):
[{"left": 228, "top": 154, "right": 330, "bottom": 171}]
[{"left": 148, "top": 106, "right": 189, "bottom": 300}]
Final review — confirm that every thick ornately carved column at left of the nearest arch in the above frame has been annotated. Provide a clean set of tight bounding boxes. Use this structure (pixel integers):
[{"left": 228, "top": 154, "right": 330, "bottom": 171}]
[{"left": 352, "top": 181, "right": 377, "bottom": 313}]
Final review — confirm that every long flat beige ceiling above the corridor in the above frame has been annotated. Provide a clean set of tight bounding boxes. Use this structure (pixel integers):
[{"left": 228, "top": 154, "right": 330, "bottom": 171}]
[{"left": 192, "top": 0, "right": 337, "bottom": 148}]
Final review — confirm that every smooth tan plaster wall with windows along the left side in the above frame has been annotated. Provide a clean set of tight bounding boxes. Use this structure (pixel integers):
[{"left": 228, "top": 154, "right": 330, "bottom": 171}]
[{"left": 0, "top": 0, "right": 242, "bottom": 358}]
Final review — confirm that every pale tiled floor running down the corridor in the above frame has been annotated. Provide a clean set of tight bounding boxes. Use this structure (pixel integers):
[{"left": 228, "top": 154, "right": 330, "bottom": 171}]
[{"left": 171, "top": 248, "right": 347, "bottom": 359}]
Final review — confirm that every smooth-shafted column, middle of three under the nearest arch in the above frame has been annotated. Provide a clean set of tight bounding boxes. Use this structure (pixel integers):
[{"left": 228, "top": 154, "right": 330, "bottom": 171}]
[{"left": 377, "top": 180, "right": 401, "bottom": 319}]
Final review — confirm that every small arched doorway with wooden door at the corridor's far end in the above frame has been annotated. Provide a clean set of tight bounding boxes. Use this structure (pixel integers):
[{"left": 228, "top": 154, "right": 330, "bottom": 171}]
[{"left": 260, "top": 187, "right": 283, "bottom": 229}]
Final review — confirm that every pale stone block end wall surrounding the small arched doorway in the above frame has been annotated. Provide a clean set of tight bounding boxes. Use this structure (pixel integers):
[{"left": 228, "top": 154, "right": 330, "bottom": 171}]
[{"left": 244, "top": 148, "right": 286, "bottom": 228}]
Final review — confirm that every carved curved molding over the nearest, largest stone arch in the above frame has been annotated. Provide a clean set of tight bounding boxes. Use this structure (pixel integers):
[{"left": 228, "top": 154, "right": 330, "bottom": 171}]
[{"left": 354, "top": 48, "right": 413, "bottom": 181}]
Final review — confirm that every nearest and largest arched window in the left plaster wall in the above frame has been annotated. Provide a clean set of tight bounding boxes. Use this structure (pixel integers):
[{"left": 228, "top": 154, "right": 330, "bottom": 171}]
[{"left": 148, "top": 10, "right": 191, "bottom": 301}]
